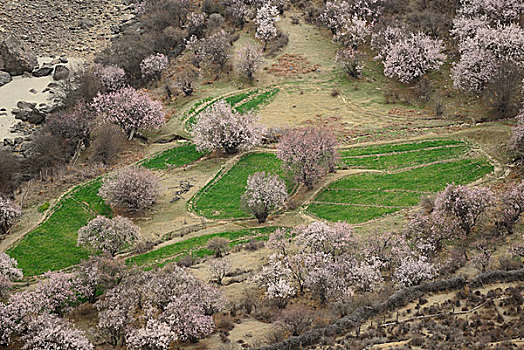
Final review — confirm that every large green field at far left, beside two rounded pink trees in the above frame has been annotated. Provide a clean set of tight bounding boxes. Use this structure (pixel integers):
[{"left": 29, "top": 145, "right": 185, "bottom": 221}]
[{"left": 7, "top": 180, "right": 112, "bottom": 276}]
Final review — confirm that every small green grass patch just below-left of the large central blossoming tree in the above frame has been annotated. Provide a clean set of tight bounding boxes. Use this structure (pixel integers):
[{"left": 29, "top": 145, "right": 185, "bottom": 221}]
[{"left": 140, "top": 143, "right": 205, "bottom": 170}]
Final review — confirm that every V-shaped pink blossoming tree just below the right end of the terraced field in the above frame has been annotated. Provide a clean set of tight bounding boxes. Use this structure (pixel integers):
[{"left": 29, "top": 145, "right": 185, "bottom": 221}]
[{"left": 434, "top": 185, "right": 493, "bottom": 236}]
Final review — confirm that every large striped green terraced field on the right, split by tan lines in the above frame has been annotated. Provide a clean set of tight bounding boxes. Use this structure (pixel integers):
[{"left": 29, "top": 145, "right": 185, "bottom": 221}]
[{"left": 306, "top": 140, "right": 493, "bottom": 224}]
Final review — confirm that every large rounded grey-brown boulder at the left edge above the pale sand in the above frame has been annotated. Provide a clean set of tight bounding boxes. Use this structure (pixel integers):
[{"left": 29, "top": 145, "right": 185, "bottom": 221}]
[{"left": 0, "top": 35, "right": 38, "bottom": 75}]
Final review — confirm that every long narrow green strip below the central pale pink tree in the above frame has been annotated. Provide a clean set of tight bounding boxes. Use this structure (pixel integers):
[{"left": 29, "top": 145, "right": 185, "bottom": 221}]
[{"left": 126, "top": 227, "right": 277, "bottom": 266}]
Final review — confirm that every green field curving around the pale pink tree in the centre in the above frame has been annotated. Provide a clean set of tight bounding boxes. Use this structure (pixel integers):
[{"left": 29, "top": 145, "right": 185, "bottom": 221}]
[{"left": 193, "top": 153, "right": 292, "bottom": 219}]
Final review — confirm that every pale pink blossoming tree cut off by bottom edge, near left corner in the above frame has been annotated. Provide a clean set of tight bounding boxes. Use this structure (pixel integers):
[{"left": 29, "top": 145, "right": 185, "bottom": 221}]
[{"left": 22, "top": 315, "right": 93, "bottom": 350}]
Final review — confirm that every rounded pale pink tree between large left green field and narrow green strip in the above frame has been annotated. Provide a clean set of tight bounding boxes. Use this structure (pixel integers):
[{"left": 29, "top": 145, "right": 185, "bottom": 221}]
[{"left": 78, "top": 215, "right": 140, "bottom": 256}]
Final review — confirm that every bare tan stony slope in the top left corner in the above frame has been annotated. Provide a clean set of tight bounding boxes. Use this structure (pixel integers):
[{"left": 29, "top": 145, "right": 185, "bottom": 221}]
[{"left": 0, "top": 0, "right": 137, "bottom": 57}]
